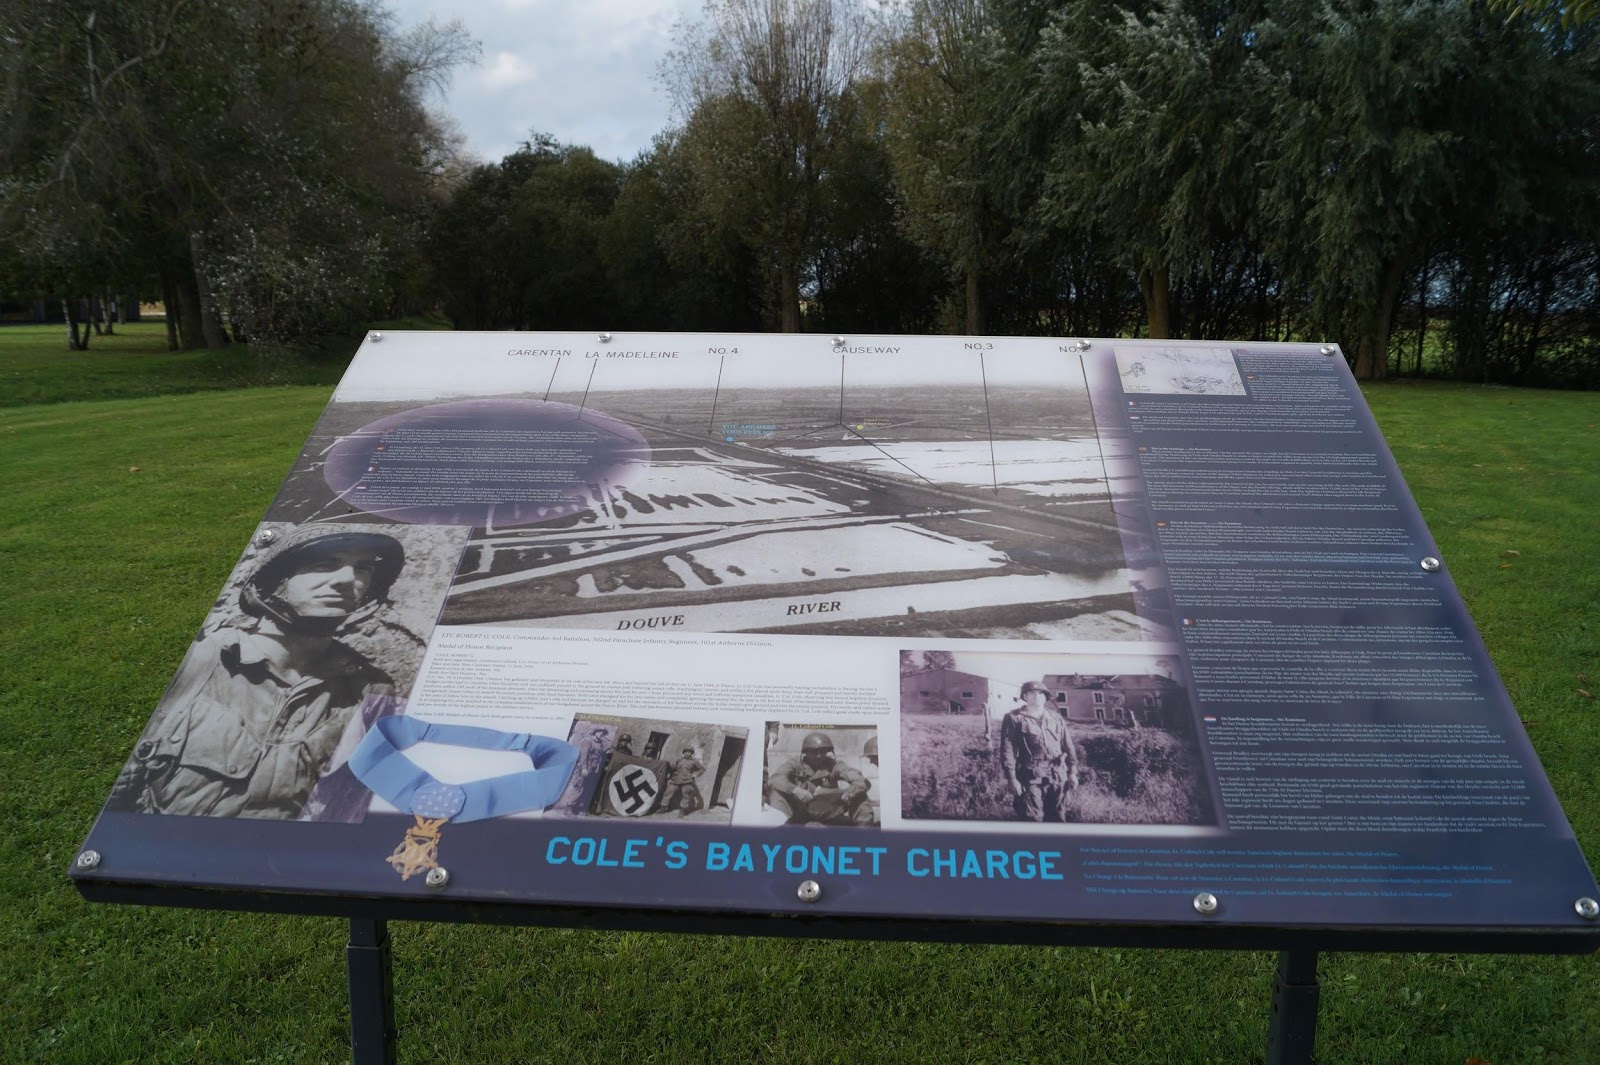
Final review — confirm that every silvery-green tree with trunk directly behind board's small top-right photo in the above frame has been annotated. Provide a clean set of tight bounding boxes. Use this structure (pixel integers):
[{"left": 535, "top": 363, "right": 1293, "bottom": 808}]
[{"left": 1026, "top": 0, "right": 1272, "bottom": 339}]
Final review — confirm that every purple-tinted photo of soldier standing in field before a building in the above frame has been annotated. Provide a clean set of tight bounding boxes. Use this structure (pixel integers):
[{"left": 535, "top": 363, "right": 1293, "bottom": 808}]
[{"left": 899, "top": 649, "right": 1214, "bottom": 825}]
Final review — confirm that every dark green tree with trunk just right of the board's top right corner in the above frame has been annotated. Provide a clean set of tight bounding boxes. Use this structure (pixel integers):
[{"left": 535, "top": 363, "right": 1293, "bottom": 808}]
[{"left": 1261, "top": 0, "right": 1504, "bottom": 379}]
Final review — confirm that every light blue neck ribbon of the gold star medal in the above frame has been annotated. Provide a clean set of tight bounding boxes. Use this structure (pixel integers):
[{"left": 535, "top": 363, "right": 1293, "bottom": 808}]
[{"left": 350, "top": 715, "right": 578, "bottom": 822}]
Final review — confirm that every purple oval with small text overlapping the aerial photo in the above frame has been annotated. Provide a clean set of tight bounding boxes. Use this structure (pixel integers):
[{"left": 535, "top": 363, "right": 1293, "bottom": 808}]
[{"left": 323, "top": 400, "right": 650, "bottom": 528}]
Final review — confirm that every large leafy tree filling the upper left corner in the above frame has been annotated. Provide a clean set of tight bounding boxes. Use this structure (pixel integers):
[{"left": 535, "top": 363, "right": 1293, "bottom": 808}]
[{"left": 0, "top": 0, "right": 475, "bottom": 347}]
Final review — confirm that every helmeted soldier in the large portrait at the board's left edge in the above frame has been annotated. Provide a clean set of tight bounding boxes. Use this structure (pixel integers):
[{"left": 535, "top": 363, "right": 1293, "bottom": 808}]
[{"left": 109, "top": 529, "right": 405, "bottom": 819}]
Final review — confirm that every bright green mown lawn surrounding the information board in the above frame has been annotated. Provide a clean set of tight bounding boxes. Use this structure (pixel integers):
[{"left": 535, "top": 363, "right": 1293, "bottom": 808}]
[{"left": 0, "top": 377, "right": 1600, "bottom": 1065}]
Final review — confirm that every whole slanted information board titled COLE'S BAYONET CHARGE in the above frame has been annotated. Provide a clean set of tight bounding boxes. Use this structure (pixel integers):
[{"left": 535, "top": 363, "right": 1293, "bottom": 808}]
[{"left": 74, "top": 333, "right": 1600, "bottom": 937}]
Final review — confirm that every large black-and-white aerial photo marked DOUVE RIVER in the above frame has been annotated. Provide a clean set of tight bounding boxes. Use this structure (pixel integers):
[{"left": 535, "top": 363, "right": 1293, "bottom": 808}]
[{"left": 406, "top": 345, "right": 1154, "bottom": 640}]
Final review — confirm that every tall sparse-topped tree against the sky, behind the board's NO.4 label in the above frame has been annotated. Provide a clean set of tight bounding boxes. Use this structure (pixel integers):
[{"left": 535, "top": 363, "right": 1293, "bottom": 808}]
[{"left": 662, "top": 0, "right": 867, "bottom": 333}]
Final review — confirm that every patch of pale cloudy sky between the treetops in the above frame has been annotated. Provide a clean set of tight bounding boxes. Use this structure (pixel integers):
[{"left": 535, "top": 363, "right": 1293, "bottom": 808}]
[{"left": 387, "top": 0, "right": 702, "bottom": 163}]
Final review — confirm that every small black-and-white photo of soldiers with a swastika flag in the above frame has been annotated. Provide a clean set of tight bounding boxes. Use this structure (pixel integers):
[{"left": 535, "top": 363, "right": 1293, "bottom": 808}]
[{"left": 546, "top": 713, "right": 749, "bottom": 824}]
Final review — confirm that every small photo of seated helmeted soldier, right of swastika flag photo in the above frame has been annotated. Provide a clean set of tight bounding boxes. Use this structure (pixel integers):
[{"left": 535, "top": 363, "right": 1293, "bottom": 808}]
[{"left": 763, "top": 721, "right": 882, "bottom": 828}]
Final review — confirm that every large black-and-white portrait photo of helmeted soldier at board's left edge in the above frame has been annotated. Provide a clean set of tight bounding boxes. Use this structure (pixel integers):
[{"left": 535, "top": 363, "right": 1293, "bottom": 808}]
[{"left": 107, "top": 523, "right": 466, "bottom": 819}]
